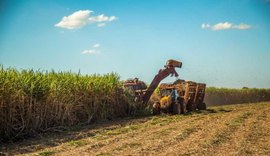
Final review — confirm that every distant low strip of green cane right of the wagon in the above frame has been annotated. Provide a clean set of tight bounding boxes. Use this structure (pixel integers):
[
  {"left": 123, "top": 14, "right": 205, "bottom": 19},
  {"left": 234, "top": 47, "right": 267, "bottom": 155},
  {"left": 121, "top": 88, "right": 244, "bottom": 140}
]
[{"left": 205, "top": 87, "right": 270, "bottom": 105}]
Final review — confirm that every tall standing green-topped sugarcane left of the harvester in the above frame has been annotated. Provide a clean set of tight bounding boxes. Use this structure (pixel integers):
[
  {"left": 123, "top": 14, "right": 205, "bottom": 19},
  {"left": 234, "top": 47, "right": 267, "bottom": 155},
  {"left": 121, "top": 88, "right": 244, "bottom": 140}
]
[{"left": 0, "top": 66, "right": 130, "bottom": 142}]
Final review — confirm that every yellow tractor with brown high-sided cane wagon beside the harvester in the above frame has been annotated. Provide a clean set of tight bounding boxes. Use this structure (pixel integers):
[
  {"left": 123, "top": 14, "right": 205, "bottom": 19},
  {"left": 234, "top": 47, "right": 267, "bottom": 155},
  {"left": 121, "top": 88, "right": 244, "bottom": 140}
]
[{"left": 153, "top": 79, "right": 206, "bottom": 114}]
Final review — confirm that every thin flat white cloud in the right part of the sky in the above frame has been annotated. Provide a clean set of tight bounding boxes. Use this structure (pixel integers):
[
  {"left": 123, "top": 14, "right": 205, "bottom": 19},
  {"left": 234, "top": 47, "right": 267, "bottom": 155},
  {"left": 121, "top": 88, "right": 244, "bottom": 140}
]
[{"left": 201, "top": 22, "right": 251, "bottom": 31}]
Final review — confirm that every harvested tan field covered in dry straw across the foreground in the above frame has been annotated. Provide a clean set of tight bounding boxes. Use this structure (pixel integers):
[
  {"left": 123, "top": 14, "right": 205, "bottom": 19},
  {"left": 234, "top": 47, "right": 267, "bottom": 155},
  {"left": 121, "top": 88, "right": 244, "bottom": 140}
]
[{"left": 0, "top": 103, "right": 270, "bottom": 156}]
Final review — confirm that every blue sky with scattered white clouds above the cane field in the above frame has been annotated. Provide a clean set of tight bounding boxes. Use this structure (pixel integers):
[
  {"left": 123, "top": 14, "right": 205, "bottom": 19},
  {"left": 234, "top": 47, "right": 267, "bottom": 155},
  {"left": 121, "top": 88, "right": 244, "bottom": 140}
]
[{"left": 0, "top": 0, "right": 270, "bottom": 88}]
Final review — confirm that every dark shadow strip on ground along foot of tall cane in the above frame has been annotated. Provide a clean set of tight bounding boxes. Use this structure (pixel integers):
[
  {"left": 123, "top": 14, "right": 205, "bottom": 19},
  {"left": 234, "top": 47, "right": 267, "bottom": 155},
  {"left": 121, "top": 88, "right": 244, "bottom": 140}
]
[{"left": 0, "top": 116, "right": 151, "bottom": 156}]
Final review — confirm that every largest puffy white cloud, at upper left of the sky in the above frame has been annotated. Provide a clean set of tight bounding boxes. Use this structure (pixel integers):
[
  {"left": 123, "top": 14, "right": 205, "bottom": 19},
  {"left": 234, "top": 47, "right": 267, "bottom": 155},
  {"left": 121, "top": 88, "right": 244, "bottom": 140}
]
[{"left": 54, "top": 10, "right": 117, "bottom": 29}]
